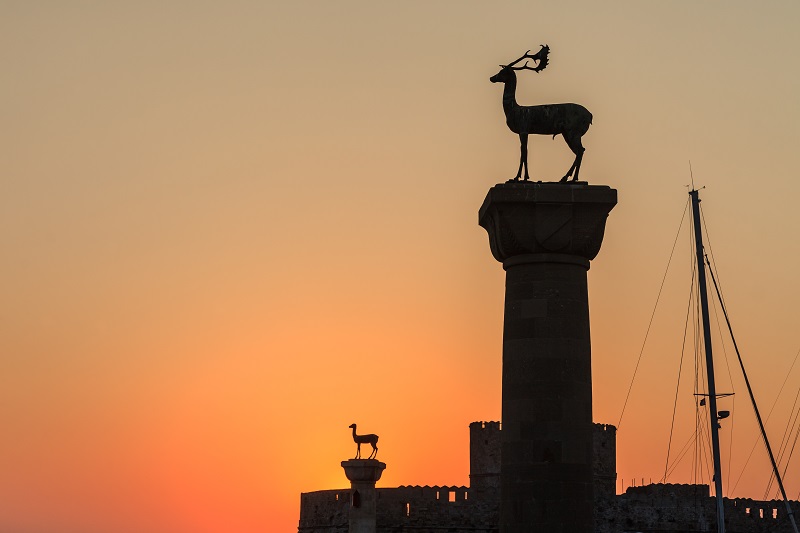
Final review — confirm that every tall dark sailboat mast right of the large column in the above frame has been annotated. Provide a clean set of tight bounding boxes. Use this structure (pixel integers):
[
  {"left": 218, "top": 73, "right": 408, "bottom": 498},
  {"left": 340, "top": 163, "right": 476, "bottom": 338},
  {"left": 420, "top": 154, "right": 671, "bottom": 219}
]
[{"left": 689, "top": 190, "right": 725, "bottom": 533}]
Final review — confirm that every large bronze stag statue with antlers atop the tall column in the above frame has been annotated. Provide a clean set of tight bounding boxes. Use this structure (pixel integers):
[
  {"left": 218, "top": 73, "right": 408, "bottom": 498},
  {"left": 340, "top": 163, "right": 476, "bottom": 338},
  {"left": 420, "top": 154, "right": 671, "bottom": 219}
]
[{"left": 489, "top": 44, "right": 592, "bottom": 182}]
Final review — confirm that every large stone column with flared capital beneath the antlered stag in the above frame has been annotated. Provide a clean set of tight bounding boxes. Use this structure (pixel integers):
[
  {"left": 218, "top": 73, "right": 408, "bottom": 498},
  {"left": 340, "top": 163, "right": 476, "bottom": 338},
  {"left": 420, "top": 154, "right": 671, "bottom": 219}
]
[{"left": 479, "top": 182, "right": 617, "bottom": 533}]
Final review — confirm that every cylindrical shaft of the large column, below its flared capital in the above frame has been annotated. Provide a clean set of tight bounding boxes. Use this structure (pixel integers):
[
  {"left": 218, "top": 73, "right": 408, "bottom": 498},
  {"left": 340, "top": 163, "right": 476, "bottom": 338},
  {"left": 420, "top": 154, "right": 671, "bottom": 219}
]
[{"left": 500, "top": 254, "right": 593, "bottom": 533}]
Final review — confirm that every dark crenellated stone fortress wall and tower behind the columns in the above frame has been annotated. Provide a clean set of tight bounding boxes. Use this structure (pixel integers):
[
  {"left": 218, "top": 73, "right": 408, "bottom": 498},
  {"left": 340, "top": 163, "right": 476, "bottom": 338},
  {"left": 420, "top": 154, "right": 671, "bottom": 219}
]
[{"left": 298, "top": 422, "right": 800, "bottom": 533}]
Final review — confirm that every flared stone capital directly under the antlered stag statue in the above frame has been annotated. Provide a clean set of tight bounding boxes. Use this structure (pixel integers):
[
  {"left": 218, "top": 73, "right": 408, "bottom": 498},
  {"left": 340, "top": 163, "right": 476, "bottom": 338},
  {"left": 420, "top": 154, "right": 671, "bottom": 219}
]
[{"left": 478, "top": 182, "right": 617, "bottom": 263}]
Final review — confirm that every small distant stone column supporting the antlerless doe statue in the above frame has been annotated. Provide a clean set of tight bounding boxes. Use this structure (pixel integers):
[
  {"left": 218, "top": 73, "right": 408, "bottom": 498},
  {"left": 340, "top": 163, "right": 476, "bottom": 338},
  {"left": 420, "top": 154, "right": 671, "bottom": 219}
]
[{"left": 342, "top": 459, "right": 386, "bottom": 533}]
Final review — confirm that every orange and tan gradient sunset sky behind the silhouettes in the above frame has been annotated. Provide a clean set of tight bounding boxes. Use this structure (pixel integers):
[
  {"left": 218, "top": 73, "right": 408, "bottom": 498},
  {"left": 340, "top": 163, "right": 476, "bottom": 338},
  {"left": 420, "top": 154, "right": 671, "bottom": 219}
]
[{"left": 0, "top": 0, "right": 800, "bottom": 533}]
